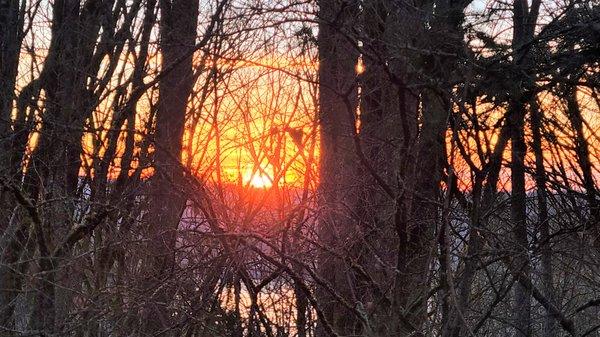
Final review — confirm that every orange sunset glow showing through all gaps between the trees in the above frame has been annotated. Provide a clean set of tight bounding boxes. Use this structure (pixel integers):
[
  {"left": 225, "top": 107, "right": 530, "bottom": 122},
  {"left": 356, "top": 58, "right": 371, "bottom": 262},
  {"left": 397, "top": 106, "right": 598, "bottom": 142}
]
[{"left": 13, "top": 47, "right": 600, "bottom": 191}]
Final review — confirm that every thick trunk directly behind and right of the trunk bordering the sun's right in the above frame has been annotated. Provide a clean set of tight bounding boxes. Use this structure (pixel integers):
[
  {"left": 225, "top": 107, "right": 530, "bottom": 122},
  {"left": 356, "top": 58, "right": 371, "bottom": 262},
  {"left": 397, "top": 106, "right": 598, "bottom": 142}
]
[{"left": 353, "top": 0, "right": 419, "bottom": 336}]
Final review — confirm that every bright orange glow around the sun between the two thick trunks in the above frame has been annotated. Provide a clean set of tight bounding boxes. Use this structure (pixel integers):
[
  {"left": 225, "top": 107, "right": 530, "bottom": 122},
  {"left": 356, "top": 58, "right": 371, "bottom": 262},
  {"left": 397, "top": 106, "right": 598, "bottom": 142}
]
[{"left": 181, "top": 53, "right": 318, "bottom": 189}]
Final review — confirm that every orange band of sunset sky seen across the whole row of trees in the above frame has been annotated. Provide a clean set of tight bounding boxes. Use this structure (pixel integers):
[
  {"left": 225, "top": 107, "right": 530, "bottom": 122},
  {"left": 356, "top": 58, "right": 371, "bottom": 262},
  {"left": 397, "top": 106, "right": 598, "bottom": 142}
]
[{"left": 16, "top": 49, "right": 600, "bottom": 189}]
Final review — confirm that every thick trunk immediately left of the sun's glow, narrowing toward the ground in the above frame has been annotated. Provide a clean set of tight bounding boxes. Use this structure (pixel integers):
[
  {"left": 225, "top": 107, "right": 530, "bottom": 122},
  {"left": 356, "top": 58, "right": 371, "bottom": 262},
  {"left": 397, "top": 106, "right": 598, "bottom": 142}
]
[{"left": 143, "top": 0, "right": 198, "bottom": 333}]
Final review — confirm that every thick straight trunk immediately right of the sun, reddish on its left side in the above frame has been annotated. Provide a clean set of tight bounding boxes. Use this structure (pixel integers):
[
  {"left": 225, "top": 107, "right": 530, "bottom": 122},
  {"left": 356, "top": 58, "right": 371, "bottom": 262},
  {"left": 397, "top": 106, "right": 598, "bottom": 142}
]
[{"left": 317, "top": 0, "right": 358, "bottom": 336}]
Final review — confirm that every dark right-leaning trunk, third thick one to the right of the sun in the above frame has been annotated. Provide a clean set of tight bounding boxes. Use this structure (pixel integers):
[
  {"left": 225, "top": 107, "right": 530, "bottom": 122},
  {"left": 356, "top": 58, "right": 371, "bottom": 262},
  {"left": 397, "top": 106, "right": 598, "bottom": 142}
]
[{"left": 386, "top": 1, "right": 468, "bottom": 333}]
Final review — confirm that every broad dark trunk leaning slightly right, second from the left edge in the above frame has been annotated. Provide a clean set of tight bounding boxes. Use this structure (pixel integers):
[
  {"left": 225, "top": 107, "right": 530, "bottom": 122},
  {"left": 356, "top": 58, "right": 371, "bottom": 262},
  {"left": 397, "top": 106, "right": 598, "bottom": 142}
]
[{"left": 19, "top": 0, "right": 118, "bottom": 334}]
